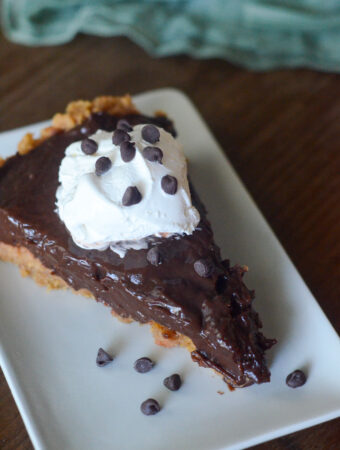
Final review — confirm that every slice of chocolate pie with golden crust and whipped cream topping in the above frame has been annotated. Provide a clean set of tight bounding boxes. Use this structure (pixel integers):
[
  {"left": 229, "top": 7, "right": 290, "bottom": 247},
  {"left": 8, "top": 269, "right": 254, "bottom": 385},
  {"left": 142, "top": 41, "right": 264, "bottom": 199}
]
[{"left": 0, "top": 96, "right": 275, "bottom": 387}]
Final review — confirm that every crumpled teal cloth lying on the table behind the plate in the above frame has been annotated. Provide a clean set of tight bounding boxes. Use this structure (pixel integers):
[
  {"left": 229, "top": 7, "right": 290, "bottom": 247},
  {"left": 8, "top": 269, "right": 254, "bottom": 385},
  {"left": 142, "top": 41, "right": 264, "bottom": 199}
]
[{"left": 1, "top": 0, "right": 340, "bottom": 71}]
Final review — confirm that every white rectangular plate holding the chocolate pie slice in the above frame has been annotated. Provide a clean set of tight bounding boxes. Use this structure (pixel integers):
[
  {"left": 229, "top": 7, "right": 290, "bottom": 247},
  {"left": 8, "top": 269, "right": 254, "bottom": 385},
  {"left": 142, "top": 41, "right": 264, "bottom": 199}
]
[{"left": 0, "top": 89, "right": 340, "bottom": 450}]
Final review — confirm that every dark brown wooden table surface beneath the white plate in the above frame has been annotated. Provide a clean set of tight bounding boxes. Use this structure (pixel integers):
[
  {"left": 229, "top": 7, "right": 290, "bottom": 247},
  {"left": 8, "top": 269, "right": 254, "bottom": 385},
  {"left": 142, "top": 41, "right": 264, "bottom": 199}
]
[{"left": 0, "top": 32, "right": 340, "bottom": 450}]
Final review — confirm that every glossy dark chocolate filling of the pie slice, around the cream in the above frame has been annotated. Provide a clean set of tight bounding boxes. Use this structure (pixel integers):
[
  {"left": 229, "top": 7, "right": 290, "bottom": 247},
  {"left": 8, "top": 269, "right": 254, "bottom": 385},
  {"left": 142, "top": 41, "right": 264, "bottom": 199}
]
[{"left": 0, "top": 114, "right": 274, "bottom": 386}]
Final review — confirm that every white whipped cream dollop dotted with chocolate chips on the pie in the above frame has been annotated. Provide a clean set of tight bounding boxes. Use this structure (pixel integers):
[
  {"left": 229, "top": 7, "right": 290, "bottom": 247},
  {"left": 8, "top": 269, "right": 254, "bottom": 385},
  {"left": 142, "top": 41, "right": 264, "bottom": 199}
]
[{"left": 56, "top": 125, "right": 200, "bottom": 257}]
